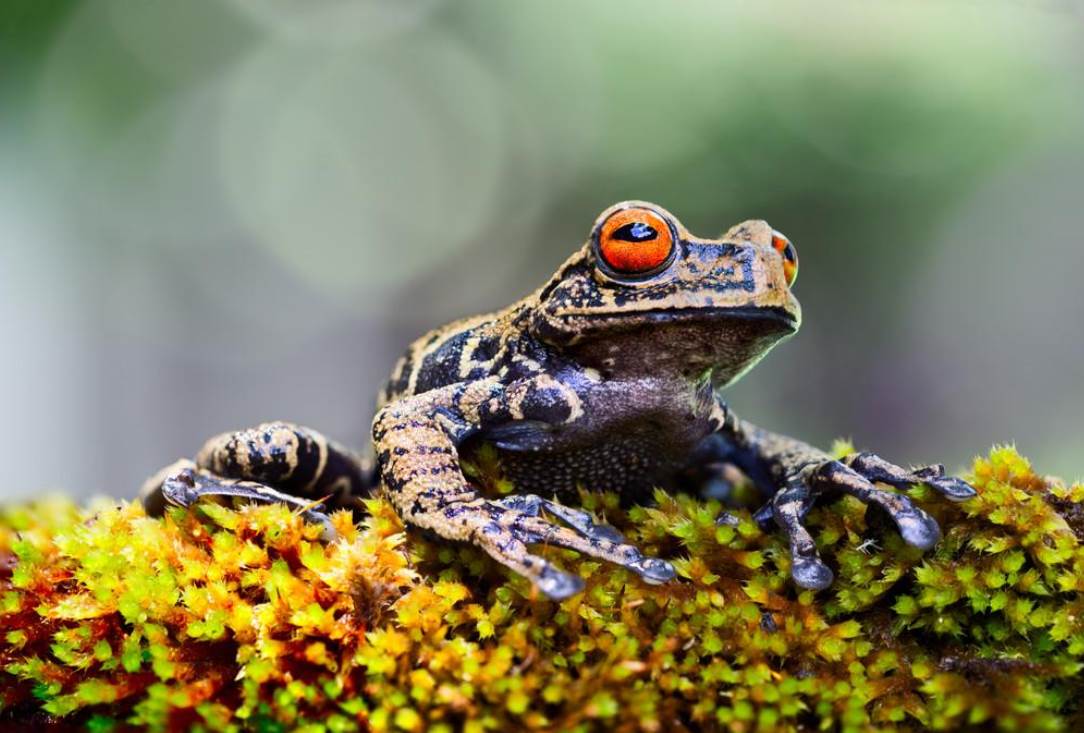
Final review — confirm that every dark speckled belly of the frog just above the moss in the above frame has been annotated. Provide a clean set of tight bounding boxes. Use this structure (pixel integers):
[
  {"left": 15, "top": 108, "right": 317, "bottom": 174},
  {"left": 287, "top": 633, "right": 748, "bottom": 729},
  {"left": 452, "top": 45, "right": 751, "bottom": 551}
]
[{"left": 498, "top": 436, "right": 682, "bottom": 503}]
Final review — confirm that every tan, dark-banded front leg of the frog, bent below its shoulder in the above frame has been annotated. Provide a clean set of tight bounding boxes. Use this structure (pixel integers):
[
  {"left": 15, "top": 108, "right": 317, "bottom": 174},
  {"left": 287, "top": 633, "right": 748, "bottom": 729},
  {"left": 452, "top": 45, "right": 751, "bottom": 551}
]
[{"left": 373, "top": 377, "right": 674, "bottom": 600}]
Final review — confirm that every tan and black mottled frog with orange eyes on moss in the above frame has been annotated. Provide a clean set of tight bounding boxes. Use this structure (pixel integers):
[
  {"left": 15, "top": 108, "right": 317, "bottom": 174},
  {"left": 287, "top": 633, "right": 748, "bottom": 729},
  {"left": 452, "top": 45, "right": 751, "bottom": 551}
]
[{"left": 142, "top": 201, "right": 976, "bottom": 601}]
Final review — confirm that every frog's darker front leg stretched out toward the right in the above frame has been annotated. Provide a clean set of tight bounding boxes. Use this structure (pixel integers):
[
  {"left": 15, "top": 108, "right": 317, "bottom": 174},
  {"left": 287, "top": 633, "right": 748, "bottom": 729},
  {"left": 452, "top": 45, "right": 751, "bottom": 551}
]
[{"left": 715, "top": 402, "right": 976, "bottom": 590}]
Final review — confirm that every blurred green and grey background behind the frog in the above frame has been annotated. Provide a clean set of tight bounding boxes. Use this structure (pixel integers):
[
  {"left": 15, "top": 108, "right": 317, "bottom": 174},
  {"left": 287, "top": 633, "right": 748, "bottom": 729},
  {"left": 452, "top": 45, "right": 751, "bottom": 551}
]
[{"left": 0, "top": 0, "right": 1084, "bottom": 499}]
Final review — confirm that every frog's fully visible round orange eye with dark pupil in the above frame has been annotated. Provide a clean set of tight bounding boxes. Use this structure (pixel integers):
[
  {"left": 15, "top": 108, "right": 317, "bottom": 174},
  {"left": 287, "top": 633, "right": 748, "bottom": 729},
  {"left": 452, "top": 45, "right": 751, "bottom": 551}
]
[{"left": 598, "top": 208, "right": 674, "bottom": 274}]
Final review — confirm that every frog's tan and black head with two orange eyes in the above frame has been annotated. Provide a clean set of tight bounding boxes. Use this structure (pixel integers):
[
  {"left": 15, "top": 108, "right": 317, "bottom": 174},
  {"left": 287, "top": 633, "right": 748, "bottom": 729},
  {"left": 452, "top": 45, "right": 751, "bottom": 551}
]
[{"left": 531, "top": 201, "right": 801, "bottom": 385}]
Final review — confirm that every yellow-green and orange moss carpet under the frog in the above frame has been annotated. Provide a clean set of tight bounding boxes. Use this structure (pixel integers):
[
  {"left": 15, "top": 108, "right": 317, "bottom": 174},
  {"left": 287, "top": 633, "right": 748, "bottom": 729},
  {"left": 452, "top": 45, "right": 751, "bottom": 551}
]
[{"left": 0, "top": 448, "right": 1084, "bottom": 731}]
